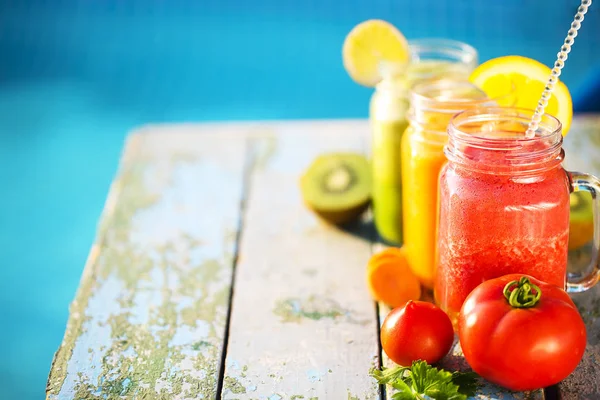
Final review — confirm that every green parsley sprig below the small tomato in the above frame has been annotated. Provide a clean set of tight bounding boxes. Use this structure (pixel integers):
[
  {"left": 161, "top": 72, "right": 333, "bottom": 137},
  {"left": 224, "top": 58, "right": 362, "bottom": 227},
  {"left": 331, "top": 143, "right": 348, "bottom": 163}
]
[{"left": 371, "top": 360, "right": 477, "bottom": 400}]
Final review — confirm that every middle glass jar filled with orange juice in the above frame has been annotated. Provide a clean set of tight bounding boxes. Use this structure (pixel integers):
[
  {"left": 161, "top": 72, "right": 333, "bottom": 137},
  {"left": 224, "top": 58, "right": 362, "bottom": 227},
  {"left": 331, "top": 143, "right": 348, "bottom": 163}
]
[{"left": 401, "top": 80, "right": 491, "bottom": 288}]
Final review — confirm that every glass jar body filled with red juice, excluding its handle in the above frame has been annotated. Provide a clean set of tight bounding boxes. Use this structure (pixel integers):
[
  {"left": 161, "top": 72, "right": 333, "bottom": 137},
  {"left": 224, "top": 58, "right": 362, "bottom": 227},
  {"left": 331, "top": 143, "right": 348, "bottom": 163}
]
[{"left": 434, "top": 108, "right": 572, "bottom": 322}]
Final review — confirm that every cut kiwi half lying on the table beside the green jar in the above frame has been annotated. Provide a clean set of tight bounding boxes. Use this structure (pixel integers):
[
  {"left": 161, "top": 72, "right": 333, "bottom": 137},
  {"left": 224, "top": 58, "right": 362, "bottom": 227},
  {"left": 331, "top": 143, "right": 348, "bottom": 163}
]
[{"left": 300, "top": 153, "right": 371, "bottom": 225}]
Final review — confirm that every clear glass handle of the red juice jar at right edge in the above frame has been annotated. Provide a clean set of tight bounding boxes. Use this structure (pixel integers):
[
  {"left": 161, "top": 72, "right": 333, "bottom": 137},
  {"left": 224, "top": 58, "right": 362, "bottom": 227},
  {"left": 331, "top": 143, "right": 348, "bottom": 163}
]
[{"left": 567, "top": 171, "right": 600, "bottom": 293}]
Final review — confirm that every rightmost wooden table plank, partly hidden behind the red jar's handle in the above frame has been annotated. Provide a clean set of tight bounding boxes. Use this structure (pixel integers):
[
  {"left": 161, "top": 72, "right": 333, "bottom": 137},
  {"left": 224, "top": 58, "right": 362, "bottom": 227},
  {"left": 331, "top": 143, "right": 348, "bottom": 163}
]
[{"left": 558, "top": 114, "right": 600, "bottom": 400}]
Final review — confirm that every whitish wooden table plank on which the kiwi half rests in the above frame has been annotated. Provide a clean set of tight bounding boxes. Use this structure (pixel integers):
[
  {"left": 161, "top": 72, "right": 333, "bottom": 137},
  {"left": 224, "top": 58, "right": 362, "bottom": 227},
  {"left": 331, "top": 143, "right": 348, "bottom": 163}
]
[{"left": 223, "top": 122, "right": 379, "bottom": 400}]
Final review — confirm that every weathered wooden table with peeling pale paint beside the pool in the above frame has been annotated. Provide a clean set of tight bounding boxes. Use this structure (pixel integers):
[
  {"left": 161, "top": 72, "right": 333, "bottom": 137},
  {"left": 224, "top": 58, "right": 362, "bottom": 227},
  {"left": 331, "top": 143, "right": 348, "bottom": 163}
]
[{"left": 47, "top": 116, "right": 600, "bottom": 400}]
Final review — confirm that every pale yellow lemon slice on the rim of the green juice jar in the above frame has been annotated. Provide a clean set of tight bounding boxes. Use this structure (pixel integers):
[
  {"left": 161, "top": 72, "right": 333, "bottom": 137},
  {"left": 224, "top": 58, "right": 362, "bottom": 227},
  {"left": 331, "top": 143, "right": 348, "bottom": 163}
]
[{"left": 342, "top": 19, "right": 410, "bottom": 87}]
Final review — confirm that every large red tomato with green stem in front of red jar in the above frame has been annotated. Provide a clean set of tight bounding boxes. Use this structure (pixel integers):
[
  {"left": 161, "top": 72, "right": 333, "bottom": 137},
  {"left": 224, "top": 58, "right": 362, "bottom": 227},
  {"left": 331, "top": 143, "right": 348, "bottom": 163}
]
[{"left": 458, "top": 274, "right": 586, "bottom": 390}]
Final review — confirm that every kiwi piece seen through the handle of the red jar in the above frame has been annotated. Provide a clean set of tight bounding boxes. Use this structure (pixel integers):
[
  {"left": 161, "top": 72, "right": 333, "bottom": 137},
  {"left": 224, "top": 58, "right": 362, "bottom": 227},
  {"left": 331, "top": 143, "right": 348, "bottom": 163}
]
[{"left": 569, "top": 191, "right": 594, "bottom": 250}]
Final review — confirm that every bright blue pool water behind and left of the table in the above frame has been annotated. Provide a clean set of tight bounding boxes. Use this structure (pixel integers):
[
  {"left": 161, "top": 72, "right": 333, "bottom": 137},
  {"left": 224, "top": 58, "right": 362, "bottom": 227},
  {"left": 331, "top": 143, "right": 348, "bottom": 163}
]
[{"left": 0, "top": 0, "right": 600, "bottom": 400}]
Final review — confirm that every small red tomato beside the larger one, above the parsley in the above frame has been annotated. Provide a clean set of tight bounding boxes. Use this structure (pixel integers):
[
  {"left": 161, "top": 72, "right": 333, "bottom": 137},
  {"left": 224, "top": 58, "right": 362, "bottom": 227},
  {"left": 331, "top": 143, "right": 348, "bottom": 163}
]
[{"left": 381, "top": 300, "right": 454, "bottom": 367}]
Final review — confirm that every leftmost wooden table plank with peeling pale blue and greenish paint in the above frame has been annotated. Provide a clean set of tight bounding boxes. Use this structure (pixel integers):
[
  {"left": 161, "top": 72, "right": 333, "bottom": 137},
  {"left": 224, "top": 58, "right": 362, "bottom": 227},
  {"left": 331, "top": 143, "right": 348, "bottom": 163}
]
[{"left": 47, "top": 127, "right": 246, "bottom": 399}]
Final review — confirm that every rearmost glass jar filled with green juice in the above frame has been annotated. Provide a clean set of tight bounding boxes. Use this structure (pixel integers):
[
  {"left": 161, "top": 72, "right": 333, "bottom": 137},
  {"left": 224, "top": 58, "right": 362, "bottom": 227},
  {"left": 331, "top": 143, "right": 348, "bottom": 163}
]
[{"left": 369, "top": 39, "right": 477, "bottom": 244}]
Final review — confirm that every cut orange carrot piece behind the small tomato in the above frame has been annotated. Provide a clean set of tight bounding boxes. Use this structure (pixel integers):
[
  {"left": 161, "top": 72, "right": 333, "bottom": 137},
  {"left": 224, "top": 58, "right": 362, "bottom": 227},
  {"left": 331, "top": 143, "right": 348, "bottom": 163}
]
[{"left": 367, "top": 248, "right": 421, "bottom": 307}]
